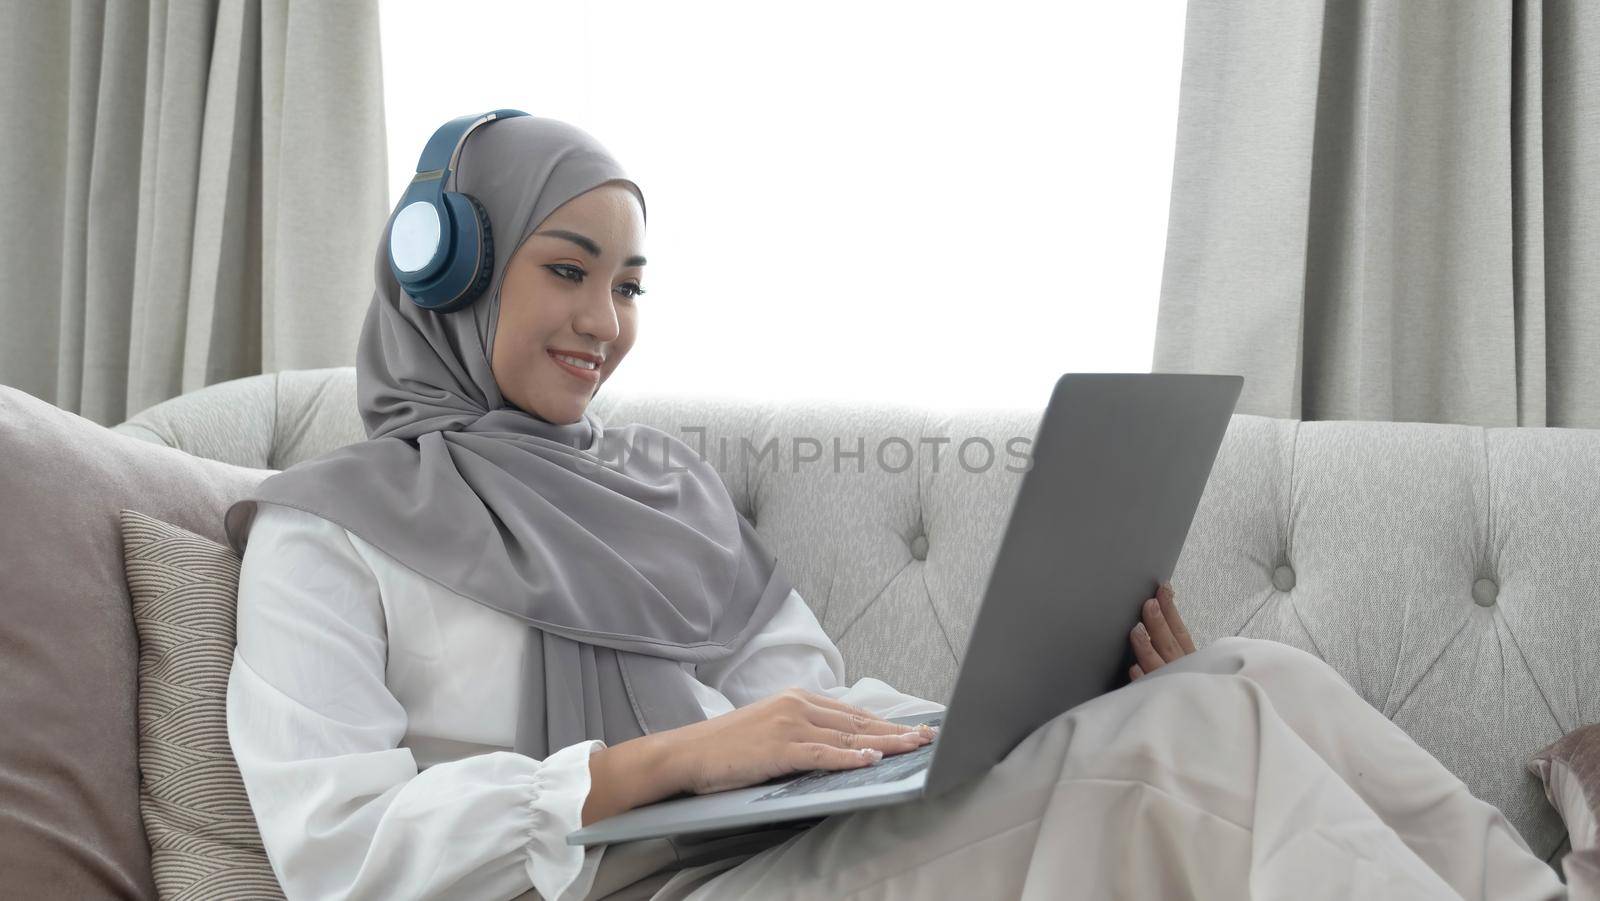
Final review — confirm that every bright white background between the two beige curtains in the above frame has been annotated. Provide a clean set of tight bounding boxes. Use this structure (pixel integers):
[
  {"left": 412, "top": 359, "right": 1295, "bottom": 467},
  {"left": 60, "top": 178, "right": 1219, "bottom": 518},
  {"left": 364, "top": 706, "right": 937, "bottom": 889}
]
[{"left": 381, "top": 0, "right": 1184, "bottom": 406}]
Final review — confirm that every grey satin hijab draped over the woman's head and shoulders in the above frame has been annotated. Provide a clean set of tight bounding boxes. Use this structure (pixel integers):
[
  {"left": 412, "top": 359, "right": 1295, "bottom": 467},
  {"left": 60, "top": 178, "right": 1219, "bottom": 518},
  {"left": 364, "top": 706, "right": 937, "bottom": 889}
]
[{"left": 226, "top": 115, "right": 792, "bottom": 759}]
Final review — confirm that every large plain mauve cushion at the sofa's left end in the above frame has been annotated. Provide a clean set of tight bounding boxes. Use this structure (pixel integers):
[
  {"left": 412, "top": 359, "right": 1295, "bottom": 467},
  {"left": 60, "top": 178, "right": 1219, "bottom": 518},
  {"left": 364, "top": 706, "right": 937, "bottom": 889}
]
[{"left": 0, "top": 386, "right": 270, "bottom": 898}]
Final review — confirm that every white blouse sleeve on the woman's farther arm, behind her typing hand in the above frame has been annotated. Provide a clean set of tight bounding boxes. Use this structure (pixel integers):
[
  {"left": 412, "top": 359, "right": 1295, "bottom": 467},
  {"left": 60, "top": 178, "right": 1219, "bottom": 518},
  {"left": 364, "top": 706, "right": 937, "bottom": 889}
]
[{"left": 694, "top": 591, "right": 944, "bottom": 717}]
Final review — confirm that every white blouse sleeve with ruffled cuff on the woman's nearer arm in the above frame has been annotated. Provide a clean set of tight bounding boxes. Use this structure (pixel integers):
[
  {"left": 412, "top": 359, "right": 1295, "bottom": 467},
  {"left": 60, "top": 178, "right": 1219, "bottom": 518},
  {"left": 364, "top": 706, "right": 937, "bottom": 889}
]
[{"left": 227, "top": 504, "right": 605, "bottom": 901}]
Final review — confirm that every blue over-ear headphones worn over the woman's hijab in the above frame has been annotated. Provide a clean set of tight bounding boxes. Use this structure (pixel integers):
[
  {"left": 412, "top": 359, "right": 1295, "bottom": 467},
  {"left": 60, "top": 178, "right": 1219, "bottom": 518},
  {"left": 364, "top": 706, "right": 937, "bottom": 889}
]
[{"left": 389, "top": 109, "right": 528, "bottom": 312}]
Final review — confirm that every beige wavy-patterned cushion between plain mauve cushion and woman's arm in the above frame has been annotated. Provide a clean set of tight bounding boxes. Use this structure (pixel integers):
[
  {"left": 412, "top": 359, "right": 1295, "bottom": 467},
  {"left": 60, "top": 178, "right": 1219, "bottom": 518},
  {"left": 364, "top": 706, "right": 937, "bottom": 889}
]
[{"left": 120, "top": 511, "right": 283, "bottom": 898}]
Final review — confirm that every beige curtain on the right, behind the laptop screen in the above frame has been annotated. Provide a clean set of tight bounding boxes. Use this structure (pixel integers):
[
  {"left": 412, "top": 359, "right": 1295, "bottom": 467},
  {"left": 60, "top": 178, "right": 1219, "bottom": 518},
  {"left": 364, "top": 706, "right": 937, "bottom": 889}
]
[{"left": 1152, "top": 0, "right": 1600, "bottom": 427}]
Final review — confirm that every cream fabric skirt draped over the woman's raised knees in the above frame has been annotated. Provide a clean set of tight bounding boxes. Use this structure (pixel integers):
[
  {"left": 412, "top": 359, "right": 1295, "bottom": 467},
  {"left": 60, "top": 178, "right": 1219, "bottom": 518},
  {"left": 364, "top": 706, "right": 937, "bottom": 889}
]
[{"left": 587, "top": 637, "right": 1566, "bottom": 901}]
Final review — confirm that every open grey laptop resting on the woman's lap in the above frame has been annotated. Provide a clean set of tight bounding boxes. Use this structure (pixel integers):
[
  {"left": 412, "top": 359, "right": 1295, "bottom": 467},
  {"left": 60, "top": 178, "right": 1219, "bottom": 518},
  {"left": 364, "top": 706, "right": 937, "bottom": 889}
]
[{"left": 566, "top": 373, "right": 1245, "bottom": 845}]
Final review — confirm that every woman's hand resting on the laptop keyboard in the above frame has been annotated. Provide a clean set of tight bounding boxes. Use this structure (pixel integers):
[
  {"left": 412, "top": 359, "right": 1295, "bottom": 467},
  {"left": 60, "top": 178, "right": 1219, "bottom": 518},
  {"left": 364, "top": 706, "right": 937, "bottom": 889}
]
[{"left": 654, "top": 688, "right": 938, "bottom": 794}]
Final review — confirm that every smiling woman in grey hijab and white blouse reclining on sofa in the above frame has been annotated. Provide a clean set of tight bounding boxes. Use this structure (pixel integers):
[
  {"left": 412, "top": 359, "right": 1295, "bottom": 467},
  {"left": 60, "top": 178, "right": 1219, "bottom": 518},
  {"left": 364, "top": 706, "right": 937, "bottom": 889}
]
[{"left": 227, "top": 117, "right": 1562, "bottom": 899}]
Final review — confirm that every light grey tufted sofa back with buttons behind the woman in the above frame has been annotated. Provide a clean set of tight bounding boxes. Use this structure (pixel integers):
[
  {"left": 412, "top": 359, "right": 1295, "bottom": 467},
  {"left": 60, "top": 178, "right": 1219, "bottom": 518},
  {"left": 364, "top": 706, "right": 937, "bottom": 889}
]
[{"left": 115, "top": 368, "right": 1600, "bottom": 863}]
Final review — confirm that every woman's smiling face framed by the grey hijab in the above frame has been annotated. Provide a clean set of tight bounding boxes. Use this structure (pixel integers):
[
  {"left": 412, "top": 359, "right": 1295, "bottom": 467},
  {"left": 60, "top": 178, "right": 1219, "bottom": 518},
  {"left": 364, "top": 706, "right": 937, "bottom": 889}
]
[{"left": 490, "top": 182, "right": 645, "bottom": 424}]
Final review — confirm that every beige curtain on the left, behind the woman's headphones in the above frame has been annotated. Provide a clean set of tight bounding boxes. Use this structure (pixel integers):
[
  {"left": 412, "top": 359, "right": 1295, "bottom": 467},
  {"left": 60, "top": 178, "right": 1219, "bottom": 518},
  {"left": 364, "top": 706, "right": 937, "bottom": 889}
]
[{"left": 0, "top": 0, "right": 389, "bottom": 426}]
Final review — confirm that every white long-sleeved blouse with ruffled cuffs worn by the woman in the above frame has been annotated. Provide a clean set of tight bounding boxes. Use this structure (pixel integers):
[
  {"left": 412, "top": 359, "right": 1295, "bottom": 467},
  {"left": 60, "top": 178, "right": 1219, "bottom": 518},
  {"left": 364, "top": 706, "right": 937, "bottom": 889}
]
[{"left": 227, "top": 503, "right": 942, "bottom": 901}]
